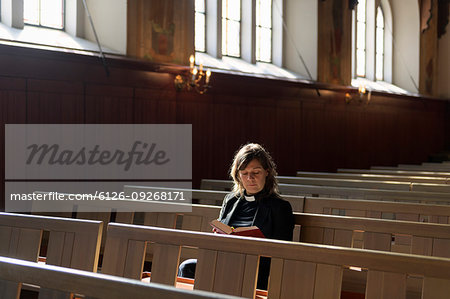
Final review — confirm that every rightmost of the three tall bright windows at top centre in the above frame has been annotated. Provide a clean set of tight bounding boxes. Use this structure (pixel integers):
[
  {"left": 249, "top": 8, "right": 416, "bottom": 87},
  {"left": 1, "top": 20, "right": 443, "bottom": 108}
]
[{"left": 256, "top": 0, "right": 272, "bottom": 62}]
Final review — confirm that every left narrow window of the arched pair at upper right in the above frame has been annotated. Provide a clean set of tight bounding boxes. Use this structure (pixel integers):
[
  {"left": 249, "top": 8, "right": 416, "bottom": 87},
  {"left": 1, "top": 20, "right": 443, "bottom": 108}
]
[{"left": 356, "top": 0, "right": 367, "bottom": 77}]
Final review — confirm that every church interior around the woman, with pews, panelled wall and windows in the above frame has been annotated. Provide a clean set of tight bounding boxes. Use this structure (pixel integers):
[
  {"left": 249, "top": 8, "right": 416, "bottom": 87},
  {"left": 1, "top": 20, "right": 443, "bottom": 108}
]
[{"left": 0, "top": 0, "right": 450, "bottom": 299}]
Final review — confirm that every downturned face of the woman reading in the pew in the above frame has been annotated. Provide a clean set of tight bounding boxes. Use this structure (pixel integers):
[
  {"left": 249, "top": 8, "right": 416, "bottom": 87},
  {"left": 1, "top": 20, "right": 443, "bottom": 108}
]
[{"left": 239, "top": 159, "right": 268, "bottom": 195}]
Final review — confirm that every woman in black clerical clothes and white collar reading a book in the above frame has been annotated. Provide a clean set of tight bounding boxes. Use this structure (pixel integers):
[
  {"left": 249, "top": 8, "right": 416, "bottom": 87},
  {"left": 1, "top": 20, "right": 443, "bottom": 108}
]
[{"left": 178, "top": 143, "right": 294, "bottom": 289}]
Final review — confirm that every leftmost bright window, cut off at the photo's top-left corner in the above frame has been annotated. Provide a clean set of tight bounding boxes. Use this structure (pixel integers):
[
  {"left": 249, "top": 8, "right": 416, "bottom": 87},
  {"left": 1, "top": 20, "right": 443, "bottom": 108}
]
[{"left": 23, "top": 0, "right": 64, "bottom": 29}]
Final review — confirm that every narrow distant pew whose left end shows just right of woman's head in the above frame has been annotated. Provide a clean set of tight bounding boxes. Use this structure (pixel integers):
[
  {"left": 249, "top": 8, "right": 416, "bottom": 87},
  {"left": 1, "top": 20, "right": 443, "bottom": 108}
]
[{"left": 296, "top": 171, "right": 450, "bottom": 184}]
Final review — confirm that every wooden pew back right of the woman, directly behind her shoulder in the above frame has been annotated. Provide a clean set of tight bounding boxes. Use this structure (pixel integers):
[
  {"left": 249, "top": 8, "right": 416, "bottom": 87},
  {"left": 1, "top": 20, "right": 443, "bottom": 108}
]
[{"left": 294, "top": 213, "right": 450, "bottom": 258}]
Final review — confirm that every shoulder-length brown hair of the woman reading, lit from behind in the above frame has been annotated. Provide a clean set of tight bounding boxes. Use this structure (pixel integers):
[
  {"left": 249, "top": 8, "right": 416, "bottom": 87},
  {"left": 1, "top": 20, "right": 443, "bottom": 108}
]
[{"left": 230, "top": 143, "right": 278, "bottom": 195}]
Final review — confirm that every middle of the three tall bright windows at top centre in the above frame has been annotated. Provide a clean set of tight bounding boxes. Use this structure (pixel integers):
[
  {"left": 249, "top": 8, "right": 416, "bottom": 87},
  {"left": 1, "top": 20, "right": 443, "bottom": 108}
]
[{"left": 222, "top": 0, "right": 241, "bottom": 57}]
